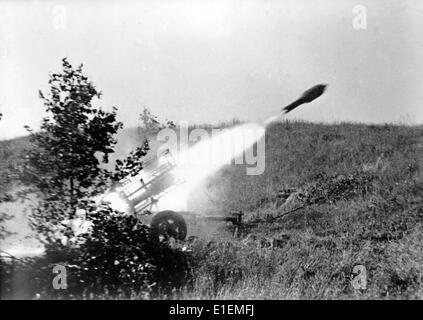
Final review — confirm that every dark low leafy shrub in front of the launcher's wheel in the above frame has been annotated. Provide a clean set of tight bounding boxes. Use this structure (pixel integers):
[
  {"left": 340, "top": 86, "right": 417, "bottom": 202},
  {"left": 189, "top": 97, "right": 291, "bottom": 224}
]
[{"left": 7, "top": 205, "right": 189, "bottom": 299}]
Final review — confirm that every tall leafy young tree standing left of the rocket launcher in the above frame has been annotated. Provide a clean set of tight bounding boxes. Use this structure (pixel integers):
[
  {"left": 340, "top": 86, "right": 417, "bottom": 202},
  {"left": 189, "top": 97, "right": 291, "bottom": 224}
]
[{"left": 22, "top": 58, "right": 122, "bottom": 242}]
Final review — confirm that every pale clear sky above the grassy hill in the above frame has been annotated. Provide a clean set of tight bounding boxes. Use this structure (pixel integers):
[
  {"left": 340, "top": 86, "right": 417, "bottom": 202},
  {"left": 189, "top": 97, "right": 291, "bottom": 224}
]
[{"left": 0, "top": 0, "right": 423, "bottom": 139}]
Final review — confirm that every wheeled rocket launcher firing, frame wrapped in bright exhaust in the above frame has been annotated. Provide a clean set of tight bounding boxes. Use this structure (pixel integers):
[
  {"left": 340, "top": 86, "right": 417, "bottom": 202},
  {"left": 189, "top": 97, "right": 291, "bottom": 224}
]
[{"left": 102, "top": 150, "right": 242, "bottom": 240}]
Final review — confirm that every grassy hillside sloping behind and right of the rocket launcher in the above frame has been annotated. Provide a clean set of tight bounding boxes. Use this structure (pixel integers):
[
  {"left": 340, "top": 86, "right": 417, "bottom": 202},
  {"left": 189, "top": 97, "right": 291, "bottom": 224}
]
[{"left": 0, "top": 122, "right": 423, "bottom": 299}]
